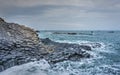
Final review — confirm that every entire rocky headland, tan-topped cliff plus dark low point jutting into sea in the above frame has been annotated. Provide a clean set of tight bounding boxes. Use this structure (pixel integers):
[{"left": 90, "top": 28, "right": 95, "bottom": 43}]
[{"left": 0, "top": 18, "right": 101, "bottom": 71}]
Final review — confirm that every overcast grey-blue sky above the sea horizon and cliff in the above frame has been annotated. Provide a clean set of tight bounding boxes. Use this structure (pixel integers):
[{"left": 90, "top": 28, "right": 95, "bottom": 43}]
[{"left": 0, "top": 0, "right": 120, "bottom": 30}]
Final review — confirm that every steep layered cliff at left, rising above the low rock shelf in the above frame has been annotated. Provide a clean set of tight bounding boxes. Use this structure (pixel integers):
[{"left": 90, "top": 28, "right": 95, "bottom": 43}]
[{"left": 0, "top": 18, "right": 44, "bottom": 71}]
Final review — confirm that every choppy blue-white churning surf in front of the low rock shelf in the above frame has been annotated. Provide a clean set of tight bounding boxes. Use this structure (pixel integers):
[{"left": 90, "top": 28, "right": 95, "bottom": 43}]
[{"left": 49, "top": 59, "right": 120, "bottom": 75}]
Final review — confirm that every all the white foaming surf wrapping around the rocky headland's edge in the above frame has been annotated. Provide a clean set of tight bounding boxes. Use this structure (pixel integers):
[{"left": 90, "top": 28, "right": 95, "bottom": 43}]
[{"left": 0, "top": 40, "right": 117, "bottom": 75}]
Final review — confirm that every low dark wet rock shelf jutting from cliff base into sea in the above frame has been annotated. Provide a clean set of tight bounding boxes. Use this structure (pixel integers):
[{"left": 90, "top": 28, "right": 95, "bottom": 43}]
[{"left": 41, "top": 38, "right": 91, "bottom": 63}]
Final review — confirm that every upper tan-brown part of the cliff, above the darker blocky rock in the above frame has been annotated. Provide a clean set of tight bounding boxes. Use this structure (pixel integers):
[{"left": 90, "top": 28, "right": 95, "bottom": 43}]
[{"left": 0, "top": 18, "right": 39, "bottom": 44}]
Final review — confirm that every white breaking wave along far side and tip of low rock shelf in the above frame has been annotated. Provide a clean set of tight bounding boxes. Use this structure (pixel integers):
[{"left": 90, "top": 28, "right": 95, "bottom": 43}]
[{"left": 54, "top": 40, "right": 113, "bottom": 53}]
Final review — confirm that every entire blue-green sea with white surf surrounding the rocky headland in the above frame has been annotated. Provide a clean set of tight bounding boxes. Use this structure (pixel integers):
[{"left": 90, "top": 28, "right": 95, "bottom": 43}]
[{"left": 0, "top": 31, "right": 120, "bottom": 75}]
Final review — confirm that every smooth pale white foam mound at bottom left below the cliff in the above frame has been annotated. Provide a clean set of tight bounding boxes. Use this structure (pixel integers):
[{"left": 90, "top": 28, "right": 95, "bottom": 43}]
[{"left": 0, "top": 59, "right": 50, "bottom": 75}]
